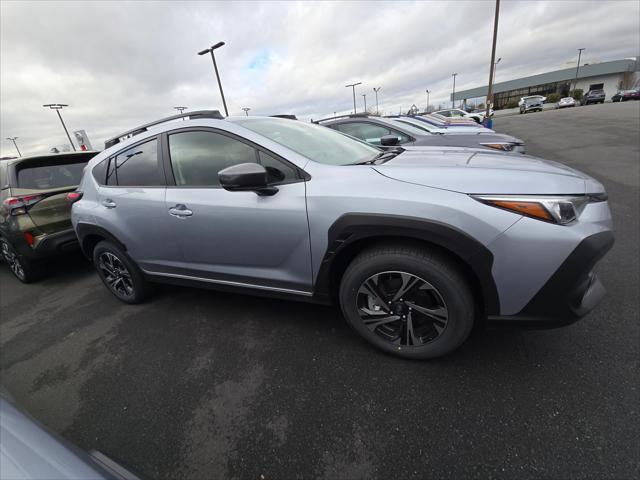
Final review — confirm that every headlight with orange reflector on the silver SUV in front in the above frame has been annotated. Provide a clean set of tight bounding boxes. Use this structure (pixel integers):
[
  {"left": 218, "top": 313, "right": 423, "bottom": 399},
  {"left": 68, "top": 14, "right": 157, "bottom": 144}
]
[{"left": 471, "top": 193, "right": 607, "bottom": 225}]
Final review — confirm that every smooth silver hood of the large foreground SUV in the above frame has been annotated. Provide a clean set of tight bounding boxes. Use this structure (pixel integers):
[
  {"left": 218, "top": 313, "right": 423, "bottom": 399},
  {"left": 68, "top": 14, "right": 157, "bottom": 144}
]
[{"left": 373, "top": 147, "right": 604, "bottom": 195}]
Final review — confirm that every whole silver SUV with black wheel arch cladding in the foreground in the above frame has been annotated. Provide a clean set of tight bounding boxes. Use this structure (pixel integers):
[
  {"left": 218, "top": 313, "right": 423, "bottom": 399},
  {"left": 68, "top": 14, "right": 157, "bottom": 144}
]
[{"left": 72, "top": 111, "right": 613, "bottom": 358}]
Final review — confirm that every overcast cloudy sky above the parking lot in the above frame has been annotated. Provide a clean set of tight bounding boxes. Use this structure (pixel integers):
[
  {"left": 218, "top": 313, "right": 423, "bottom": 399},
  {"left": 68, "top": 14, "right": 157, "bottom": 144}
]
[{"left": 0, "top": 0, "right": 640, "bottom": 156}]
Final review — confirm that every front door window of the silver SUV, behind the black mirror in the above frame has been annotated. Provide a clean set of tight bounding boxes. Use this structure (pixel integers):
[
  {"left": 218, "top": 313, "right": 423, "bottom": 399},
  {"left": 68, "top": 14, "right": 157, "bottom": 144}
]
[{"left": 169, "top": 130, "right": 260, "bottom": 187}]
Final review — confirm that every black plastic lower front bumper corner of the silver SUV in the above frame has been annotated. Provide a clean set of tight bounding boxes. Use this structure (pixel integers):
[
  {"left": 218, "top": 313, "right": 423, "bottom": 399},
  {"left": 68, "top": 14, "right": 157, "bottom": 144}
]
[{"left": 488, "top": 231, "right": 614, "bottom": 328}]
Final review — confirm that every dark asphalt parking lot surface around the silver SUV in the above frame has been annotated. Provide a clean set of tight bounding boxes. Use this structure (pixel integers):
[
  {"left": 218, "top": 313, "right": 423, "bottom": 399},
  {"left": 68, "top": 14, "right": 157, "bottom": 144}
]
[{"left": 0, "top": 102, "right": 640, "bottom": 479}]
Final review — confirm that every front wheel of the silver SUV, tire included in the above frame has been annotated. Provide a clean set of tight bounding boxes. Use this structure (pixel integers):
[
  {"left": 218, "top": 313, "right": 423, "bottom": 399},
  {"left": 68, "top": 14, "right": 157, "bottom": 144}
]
[{"left": 339, "top": 245, "right": 474, "bottom": 359}]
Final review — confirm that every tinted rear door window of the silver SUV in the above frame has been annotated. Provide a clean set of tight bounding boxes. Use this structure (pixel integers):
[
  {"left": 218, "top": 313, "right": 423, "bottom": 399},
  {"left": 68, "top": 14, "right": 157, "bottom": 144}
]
[{"left": 107, "top": 138, "right": 164, "bottom": 187}]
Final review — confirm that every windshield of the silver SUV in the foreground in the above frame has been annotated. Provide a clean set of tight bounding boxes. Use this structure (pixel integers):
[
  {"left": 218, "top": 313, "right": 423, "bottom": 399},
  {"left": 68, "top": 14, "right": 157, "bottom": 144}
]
[{"left": 235, "top": 118, "right": 381, "bottom": 165}]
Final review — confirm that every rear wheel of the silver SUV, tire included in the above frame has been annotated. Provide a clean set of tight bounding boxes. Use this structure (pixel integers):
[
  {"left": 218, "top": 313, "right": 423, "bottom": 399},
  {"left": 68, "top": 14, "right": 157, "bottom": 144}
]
[{"left": 92, "top": 240, "right": 151, "bottom": 304}]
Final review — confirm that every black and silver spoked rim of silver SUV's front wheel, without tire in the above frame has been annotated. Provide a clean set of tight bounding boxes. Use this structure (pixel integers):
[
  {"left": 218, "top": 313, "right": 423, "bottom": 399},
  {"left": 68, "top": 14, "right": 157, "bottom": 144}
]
[{"left": 356, "top": 271, "right": 449, "bottom": 347}]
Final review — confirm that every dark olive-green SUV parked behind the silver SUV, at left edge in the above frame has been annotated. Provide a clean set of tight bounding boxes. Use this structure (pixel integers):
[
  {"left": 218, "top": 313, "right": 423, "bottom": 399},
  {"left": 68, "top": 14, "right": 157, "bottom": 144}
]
[{"left": 0, "top": 152, "right": 98, "bottom": 283}]
